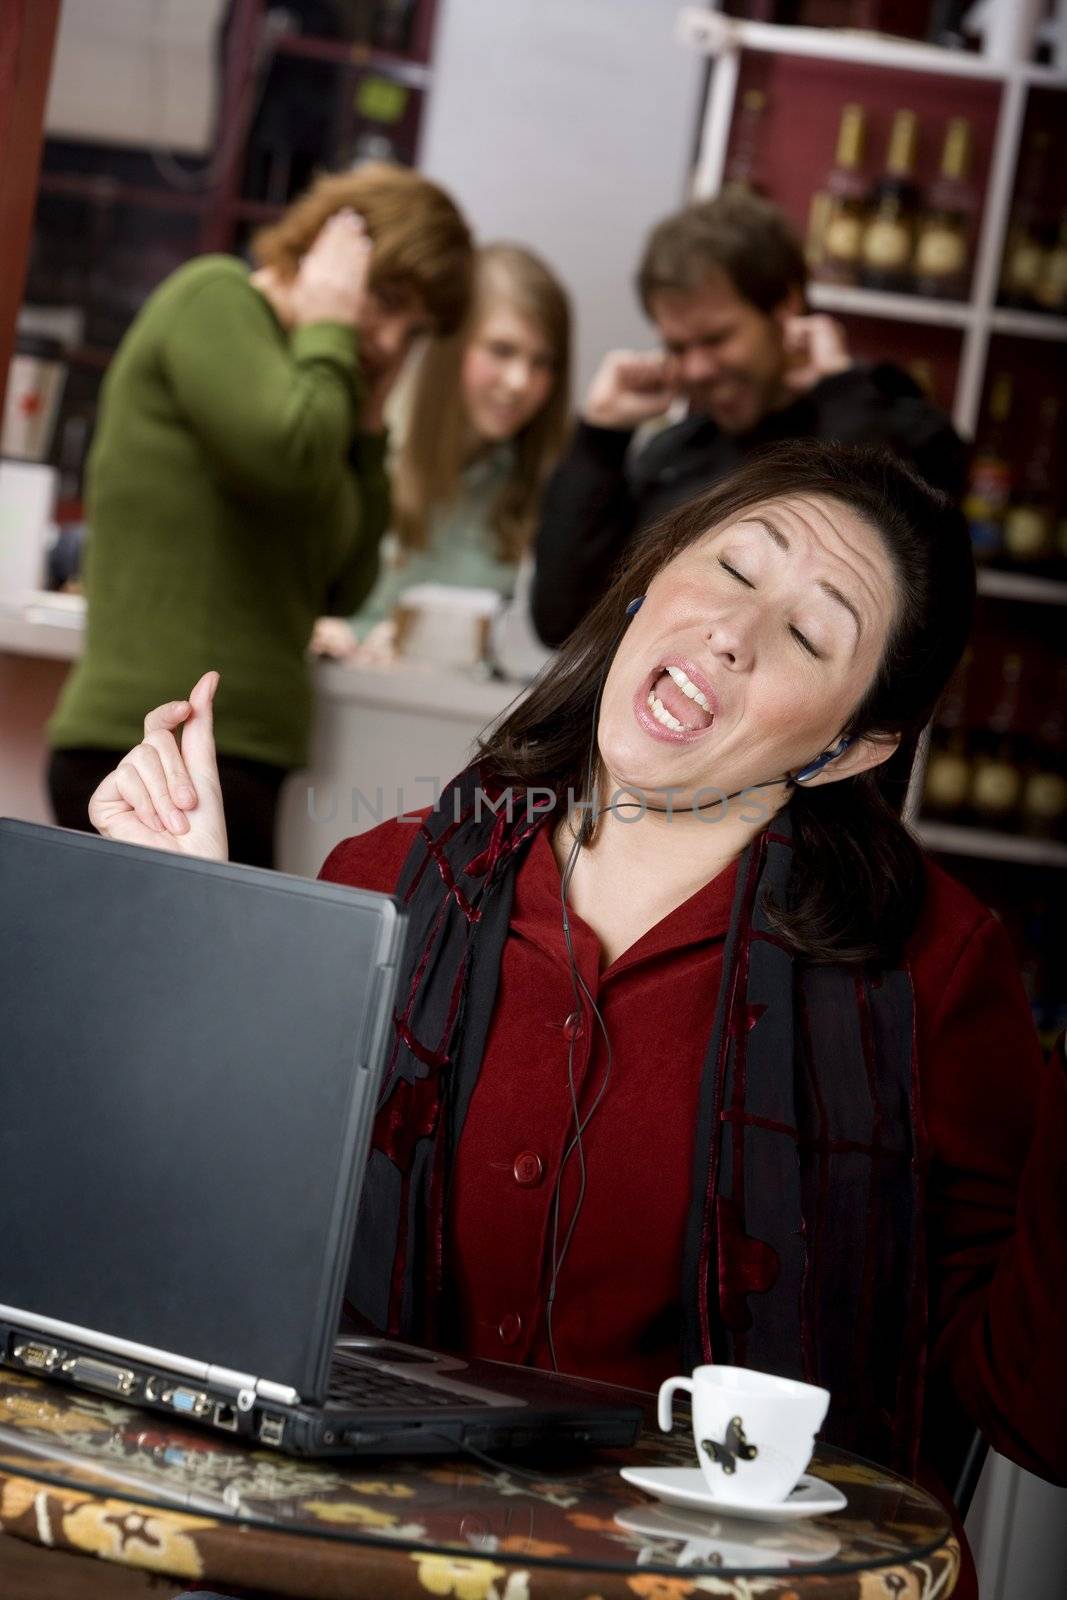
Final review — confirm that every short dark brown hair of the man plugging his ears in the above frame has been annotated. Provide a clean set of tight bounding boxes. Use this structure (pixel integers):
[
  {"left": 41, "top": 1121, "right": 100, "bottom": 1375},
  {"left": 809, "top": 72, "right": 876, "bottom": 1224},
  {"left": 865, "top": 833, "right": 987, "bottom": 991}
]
[{"left": 637, "top": 189, "right": 808, "bottom": 317}]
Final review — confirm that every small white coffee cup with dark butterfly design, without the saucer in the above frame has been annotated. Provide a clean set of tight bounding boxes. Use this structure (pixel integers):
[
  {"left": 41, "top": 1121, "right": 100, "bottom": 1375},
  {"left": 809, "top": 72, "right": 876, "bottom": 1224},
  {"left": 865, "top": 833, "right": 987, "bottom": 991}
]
[{"left": 659, "top": 1366, "right": 830, "bottom": 1506}]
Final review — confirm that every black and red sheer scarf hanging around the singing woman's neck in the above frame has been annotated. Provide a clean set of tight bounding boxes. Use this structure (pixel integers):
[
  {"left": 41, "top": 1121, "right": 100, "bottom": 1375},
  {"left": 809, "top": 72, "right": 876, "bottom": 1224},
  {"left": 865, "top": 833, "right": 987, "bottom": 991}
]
[{"left": 349, "top": 768, "right": 926, "bottom": 1472}]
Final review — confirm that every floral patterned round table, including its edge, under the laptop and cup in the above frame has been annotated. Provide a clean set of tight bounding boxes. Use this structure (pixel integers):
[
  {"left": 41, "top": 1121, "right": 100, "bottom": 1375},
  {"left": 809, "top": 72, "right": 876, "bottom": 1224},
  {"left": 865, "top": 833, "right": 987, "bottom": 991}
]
[{"left": 0, "top": 1373, "right": 960, "bottom": 1600}]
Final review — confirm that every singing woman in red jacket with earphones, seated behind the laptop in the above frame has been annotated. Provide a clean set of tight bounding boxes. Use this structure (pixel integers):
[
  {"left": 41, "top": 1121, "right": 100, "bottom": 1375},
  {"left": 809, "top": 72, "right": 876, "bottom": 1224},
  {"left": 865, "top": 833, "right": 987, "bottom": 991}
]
[{"left": 91, "top": 445, "right": 1067, "bottom": 1600}]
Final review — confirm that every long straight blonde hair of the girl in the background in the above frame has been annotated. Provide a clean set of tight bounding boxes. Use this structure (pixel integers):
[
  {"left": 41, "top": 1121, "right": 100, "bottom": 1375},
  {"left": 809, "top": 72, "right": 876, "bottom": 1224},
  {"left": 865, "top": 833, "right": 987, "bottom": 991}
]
[{"left": 394, "top": 245, "right": 571, "bottom": 562}]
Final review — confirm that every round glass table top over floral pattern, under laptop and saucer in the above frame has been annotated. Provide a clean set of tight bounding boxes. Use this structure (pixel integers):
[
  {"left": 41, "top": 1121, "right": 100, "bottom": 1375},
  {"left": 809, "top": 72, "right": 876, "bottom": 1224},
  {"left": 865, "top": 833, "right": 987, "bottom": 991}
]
[{"left": 0, "top": 1371, "right": 952, "bottom": 1576}]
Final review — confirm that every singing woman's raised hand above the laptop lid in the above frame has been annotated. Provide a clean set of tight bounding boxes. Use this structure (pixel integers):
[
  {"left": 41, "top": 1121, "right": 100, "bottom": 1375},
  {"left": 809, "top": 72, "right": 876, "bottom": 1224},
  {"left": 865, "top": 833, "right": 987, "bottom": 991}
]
[{"left": 90, "top": 672, "right": 229, "bottom": 861}]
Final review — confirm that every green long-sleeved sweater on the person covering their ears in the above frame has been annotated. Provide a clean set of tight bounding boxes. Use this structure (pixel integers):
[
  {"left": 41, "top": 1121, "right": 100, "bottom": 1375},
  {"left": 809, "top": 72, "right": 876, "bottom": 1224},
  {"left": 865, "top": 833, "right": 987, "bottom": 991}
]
[{"left": 48, "top": 256, "right": 389, "bottom": 766}]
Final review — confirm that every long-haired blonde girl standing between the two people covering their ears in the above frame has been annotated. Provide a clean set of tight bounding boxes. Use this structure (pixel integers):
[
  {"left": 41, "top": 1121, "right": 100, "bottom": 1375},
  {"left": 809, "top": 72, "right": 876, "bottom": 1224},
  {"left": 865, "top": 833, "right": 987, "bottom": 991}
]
[{"left": 315, "top": 245, "right": 571, "bottom": 661}]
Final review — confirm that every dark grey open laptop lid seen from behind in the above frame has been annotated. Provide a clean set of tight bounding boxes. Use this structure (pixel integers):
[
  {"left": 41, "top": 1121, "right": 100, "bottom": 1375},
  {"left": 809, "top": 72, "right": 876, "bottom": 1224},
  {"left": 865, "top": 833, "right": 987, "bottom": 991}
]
[{"left": 0, "top": 822, "right": 403, "bottom": 1398}]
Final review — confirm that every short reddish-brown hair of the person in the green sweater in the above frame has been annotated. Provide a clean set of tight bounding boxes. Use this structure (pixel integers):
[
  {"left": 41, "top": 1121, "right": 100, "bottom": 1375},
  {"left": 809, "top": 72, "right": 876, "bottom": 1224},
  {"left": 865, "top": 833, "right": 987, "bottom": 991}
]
[{"left": 253, "top": 162, "right": 472, "bottom": 334}]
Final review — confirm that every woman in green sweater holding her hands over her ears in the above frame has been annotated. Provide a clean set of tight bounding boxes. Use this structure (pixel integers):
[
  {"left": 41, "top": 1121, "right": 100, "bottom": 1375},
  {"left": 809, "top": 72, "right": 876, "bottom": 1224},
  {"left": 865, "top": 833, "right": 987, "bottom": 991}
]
[{"left": 48, "top": 165, "right": 470, "bottom": 866}]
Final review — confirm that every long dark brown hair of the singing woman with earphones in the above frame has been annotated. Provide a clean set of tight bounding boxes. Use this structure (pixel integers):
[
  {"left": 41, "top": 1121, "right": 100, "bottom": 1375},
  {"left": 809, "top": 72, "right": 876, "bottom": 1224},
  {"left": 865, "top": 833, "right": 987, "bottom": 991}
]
[{"left": 482, "top": 440, "right": 974, "bottom": 962}]
